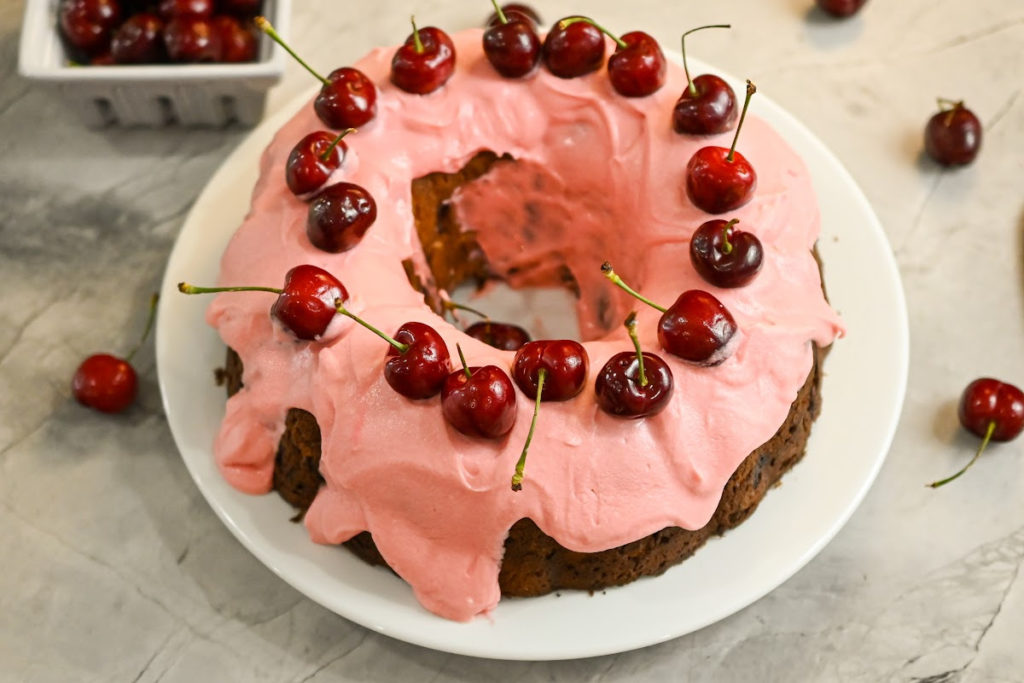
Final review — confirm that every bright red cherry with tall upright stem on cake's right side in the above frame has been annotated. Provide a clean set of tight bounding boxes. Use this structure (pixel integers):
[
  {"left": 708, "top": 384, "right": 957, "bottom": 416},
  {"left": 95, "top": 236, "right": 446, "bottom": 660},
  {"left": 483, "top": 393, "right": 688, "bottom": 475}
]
[{"left": 686, "top": 146, "right": 758, "bottom": 213}]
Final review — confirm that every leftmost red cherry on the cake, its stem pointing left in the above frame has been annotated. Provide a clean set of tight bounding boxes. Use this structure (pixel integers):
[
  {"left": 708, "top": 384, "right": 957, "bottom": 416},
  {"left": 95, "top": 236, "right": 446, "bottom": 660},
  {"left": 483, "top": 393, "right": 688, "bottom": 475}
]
[{"left": 270, "top": 265, "right": 348, "bottom": 340}]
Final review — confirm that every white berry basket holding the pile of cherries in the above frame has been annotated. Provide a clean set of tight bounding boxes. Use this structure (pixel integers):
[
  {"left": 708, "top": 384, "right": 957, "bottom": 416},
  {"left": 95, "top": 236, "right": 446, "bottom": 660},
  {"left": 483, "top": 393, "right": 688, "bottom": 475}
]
[{"left": 18, "top": 0, "right": 291, "bottom": 127}]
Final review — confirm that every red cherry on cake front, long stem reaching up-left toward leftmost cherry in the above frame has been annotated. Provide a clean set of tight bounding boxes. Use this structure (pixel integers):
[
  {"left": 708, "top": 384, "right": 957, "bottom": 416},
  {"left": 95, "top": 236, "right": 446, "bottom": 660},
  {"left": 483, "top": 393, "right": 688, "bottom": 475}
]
[{"left": 384, "top": 322, "right": 452, "bottom": 398}]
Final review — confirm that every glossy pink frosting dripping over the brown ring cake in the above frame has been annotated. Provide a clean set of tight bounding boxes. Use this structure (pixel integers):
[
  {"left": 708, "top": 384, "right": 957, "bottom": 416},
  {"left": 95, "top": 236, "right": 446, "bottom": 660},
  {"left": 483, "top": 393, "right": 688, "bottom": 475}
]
[{"left": 208, "top": 31, "right": 842, "bottom": 620}]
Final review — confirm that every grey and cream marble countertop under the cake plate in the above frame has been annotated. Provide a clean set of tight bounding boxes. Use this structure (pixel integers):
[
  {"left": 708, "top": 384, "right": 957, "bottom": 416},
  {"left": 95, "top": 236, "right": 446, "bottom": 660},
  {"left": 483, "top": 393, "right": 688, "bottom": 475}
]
[{"left": 0, "top": 0, "right": 1024, "bottom": 683}]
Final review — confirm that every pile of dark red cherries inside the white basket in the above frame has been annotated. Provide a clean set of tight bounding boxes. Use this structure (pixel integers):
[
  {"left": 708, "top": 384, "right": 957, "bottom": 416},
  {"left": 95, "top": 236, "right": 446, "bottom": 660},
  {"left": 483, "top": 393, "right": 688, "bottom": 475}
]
[{"left": 57, "top": 0, "right": 262, "bottom": 65}]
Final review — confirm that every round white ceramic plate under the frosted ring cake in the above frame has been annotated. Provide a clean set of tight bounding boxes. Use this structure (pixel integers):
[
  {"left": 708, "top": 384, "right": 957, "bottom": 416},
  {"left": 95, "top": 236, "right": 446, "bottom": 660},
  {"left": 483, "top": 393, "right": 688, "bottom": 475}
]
[{"left": 157, "top": 60, "right": 908, "bottom": 659}]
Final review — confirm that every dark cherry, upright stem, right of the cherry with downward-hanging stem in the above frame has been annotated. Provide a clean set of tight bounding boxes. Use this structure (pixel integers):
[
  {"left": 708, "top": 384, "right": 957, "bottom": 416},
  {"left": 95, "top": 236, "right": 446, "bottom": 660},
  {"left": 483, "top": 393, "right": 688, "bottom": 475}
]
[{"left": 594, "top": 351, "right": 675, "bottom": 418}]
